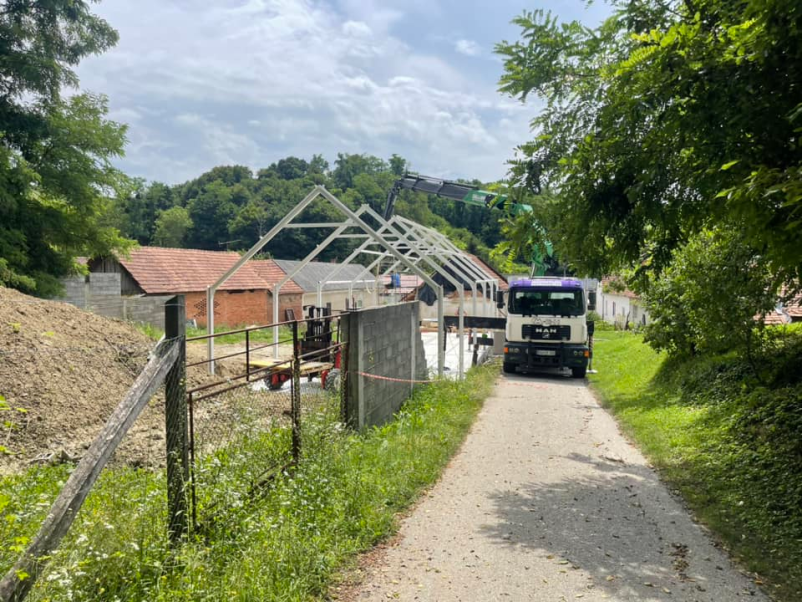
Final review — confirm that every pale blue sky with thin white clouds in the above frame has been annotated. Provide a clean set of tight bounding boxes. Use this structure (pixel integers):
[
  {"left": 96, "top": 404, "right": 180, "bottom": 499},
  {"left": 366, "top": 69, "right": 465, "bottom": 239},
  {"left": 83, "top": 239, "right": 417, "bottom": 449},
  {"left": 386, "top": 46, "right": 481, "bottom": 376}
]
[{"left": 78, "top": 0, "right": 609, "bottom": 184}]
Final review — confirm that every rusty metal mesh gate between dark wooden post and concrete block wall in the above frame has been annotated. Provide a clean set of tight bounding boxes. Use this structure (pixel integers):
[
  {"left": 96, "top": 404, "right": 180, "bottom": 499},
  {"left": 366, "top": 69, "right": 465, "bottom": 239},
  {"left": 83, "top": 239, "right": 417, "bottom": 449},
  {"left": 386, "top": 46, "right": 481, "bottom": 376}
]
[{"left": 187, "top": 310, "right": 344, "bottom": 528}]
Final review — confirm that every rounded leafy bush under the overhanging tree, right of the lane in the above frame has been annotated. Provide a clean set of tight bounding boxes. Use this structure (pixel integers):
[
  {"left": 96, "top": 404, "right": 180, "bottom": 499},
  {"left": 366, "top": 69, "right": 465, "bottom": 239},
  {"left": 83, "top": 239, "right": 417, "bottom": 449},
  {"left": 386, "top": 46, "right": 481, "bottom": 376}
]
[{"left": 646, "top": 226, "right": 777, "bottom": 358}]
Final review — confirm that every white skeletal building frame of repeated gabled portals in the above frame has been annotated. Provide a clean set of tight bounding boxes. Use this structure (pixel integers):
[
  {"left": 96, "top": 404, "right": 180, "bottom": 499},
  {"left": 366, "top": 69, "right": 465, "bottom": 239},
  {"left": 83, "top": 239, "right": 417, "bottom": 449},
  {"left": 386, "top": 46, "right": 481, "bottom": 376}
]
[{"left": 206, "top": 186, "right": 498, "bottom": 377}]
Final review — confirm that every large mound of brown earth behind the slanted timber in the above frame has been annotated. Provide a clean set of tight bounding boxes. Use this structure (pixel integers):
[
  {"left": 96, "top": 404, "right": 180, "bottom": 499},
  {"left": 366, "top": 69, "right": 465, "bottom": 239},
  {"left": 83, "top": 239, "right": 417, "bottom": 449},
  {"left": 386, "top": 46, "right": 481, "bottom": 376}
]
[{"left": 0, "top": 287, "right": 154, "bottom": 472}]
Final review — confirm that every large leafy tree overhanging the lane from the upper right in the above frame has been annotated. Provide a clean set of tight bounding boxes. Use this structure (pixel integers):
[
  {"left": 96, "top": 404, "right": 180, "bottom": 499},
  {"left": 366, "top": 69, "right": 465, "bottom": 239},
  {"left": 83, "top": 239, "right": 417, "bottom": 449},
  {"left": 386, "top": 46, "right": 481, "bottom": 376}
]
[{"left": 497, "top": 0, "right": 802, "bottom": 282}]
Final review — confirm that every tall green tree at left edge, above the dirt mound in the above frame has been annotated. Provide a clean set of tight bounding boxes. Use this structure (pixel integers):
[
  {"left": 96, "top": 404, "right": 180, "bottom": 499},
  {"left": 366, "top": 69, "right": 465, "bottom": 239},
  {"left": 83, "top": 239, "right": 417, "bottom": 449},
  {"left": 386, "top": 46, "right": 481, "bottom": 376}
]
[{"left": 0, "top": 0, "right": 129, "bottom": 296}]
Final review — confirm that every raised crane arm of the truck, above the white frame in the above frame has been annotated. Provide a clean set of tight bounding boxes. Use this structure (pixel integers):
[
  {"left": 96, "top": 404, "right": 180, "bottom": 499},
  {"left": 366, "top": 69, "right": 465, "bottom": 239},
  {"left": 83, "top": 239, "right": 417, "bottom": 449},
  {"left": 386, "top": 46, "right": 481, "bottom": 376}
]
[{"left": 384, "top": 173, "right": 552, "bottom": 276}]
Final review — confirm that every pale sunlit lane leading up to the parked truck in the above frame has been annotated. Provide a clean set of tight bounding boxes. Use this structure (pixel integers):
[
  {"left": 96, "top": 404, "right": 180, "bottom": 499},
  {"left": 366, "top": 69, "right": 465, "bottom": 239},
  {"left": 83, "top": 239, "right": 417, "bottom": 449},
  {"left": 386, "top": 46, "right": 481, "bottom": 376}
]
[{"left": 354, "top": 376, "right": 767, "bottom": 602}]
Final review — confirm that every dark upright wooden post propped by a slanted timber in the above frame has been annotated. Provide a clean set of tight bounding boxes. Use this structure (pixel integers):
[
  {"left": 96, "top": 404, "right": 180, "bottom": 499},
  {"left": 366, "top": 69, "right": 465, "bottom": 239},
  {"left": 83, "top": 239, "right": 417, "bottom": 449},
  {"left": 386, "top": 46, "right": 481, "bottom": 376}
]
[{"left": 164, "top": 295, "right": 189, "bottom": 542}]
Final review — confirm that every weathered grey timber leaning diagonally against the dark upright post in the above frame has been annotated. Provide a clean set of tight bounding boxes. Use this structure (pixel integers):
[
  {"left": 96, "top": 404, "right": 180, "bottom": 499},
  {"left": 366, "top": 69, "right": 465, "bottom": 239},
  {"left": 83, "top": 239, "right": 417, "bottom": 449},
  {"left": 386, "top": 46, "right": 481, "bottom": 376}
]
[{"left": 0, "top": 342, "right": 179, "bottom": 602}]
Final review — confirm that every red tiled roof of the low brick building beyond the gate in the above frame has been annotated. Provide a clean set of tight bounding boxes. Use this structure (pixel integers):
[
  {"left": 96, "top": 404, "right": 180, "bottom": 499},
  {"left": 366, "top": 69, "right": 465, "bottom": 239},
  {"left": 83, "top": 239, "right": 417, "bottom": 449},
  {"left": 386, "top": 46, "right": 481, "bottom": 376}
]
[{"left": 119, "top": 247, "right": 270, "bottom": 295}]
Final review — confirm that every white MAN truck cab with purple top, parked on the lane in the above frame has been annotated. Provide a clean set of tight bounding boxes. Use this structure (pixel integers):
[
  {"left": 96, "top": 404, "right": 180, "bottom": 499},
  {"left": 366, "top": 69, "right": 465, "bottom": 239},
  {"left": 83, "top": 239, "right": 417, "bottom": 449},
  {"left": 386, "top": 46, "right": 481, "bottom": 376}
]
[{"left": 498, "top": 277, "right": 595, "bottom": 378}]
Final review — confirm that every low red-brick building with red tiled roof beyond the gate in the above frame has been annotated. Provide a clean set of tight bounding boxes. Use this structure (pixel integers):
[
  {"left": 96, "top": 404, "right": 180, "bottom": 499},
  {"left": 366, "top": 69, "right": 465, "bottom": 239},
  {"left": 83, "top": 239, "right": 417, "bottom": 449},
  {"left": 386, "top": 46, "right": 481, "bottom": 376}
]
[{"left": 89, "top": 247, "right": 297, "bottom": 327}]
